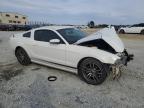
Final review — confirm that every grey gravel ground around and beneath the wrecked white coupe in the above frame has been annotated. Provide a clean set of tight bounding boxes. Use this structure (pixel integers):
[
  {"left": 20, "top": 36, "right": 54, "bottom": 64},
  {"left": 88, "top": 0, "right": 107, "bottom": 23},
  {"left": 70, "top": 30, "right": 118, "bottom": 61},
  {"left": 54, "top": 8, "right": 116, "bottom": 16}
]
[{"left": 0, "top": 32, "right": 144, "bottom": 108}]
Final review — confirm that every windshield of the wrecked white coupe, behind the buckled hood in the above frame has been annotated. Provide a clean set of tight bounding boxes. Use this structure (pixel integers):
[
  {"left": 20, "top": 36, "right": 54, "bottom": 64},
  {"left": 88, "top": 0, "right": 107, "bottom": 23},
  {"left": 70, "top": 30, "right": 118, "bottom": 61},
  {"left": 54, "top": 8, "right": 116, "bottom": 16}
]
[{"left": 57, "top": 28, "right": 87, "bottom": 44}]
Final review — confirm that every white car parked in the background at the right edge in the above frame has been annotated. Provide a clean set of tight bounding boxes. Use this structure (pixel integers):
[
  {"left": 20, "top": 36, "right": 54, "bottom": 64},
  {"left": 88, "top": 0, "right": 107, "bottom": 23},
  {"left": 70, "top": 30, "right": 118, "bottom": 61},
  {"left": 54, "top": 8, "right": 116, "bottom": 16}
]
[{"left": 118, "top": 24, "right": 144, "bottom": 34}]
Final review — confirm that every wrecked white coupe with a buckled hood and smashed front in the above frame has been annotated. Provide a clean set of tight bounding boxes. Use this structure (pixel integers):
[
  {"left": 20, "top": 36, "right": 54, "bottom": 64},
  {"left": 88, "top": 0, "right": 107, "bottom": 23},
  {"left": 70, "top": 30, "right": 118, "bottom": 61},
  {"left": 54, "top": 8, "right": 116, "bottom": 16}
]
[{"left": 10, "top": 26, "right": 133, "bottom": 85}]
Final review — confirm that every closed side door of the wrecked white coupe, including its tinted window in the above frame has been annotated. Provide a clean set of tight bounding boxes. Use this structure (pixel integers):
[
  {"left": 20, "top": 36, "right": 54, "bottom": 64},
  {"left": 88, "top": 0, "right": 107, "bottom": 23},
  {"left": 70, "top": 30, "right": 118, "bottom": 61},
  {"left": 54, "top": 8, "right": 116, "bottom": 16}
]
[{"left": 31, "top": 29, "right": 66, "bottom": 65}]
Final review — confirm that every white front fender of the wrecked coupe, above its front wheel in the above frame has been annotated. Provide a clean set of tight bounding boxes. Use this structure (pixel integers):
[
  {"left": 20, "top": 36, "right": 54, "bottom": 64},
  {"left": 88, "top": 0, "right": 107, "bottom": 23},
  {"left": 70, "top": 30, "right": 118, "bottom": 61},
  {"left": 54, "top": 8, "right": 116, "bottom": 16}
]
[{"left": 66, "top": 45, "right": 120, "bottom": 67}]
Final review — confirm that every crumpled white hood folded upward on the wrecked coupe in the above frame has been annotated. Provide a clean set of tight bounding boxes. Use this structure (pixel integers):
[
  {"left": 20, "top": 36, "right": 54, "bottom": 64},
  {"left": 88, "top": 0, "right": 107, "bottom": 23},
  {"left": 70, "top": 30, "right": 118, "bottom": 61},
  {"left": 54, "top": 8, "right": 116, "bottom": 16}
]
[{"left": 75, "top": 27, "right": 124, "bottom": 52}]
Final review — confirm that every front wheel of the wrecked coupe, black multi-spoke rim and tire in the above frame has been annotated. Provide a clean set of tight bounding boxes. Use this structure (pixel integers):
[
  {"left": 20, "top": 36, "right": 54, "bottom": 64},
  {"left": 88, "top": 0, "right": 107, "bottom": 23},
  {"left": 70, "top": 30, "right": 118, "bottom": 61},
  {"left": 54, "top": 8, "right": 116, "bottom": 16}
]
[{"left": 78, "top": 58, "right": 107, "bottom": 85}]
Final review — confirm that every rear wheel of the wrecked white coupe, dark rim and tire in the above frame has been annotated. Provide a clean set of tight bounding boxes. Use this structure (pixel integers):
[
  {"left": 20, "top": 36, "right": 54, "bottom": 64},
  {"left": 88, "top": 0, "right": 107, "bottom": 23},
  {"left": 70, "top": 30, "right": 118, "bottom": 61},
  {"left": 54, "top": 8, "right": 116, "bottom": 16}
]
[{"left": 15, "top": 48, "right": 31, "bottom": 66}]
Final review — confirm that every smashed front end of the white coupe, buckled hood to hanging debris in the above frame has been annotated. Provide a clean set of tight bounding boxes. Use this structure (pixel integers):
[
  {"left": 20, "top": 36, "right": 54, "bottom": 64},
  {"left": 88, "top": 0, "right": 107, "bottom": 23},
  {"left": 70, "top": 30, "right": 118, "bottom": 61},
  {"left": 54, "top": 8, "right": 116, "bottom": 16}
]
[{"left": 75, "top": 27, "right": 134, "bottom": 79}]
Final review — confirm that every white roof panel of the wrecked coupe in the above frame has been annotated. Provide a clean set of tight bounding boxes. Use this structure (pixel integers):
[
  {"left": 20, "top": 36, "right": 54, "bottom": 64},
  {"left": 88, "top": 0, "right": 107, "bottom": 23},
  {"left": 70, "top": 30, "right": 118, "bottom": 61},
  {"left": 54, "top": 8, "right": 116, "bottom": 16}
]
[{"left": 33, "top": 26, "right": 74, "bottom": 30}]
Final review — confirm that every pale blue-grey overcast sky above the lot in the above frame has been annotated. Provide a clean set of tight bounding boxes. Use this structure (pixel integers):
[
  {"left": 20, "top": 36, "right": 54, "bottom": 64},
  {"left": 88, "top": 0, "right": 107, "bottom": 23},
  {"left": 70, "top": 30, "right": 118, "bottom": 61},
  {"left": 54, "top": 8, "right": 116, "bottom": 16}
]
[{"left": 0, "top": 0, "right": 144, "bottom": 24}]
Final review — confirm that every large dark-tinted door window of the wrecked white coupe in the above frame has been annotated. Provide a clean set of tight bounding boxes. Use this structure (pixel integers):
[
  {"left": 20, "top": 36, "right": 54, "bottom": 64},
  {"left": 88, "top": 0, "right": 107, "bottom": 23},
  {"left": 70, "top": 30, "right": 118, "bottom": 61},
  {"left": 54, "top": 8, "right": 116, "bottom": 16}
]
[{"left": 34, "top": 30, "right": 64, "bottom": 44}]
